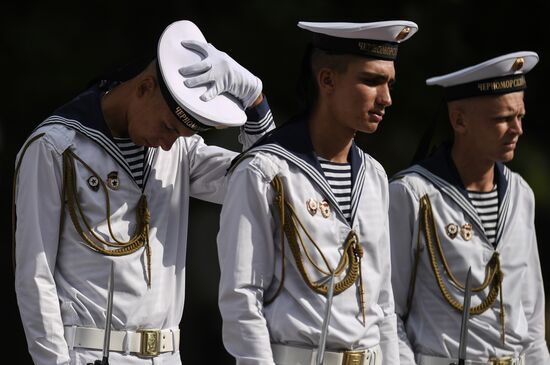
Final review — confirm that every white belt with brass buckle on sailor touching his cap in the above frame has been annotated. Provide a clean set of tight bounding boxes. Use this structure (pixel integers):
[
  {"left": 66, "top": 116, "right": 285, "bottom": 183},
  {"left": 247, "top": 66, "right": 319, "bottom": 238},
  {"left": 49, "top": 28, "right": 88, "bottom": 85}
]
[{"left": 65, "top": 326, "right": 180, "bottom": 357}]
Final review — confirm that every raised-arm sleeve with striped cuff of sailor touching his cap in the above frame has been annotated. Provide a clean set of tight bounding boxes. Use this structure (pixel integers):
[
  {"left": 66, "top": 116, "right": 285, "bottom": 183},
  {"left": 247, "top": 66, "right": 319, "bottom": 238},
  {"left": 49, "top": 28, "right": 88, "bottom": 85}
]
[{"left": 188, "top": 97, "right": 275, "bottom": 204}]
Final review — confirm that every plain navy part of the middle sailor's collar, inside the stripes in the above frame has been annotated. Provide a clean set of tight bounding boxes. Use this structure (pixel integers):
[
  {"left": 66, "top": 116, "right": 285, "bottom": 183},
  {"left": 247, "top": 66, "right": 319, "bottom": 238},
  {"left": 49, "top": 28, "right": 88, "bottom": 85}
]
[{"left": 248, "top": 116, "right": 362, "bottom": 183}]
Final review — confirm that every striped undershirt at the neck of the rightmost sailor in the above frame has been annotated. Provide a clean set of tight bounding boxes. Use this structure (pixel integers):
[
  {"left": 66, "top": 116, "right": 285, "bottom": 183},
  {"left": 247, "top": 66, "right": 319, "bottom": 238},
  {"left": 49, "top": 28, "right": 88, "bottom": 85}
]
[{"left": 468, "top": 184, "right": 498, "bottom": 246}]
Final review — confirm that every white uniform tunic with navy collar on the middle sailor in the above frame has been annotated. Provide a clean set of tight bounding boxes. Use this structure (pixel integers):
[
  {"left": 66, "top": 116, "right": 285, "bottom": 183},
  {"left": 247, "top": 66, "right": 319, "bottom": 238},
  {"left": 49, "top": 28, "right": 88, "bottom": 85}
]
[{"left": 218, "top": 119, "right": 399, "bottom": 364}]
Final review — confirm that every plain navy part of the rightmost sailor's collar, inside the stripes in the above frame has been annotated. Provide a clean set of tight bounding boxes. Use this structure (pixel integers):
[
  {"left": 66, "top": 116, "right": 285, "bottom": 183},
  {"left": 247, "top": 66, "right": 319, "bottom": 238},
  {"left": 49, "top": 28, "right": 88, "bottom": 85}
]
[{"left": 418, "top": 143, "right": 508, "bottom": 201}]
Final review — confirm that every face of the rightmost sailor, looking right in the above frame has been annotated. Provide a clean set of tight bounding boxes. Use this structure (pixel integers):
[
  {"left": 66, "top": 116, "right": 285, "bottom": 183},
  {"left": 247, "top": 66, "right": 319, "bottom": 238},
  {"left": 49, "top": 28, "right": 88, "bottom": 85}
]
[{"left": 464, "top": 91, "right": 525, "bottom": 162}]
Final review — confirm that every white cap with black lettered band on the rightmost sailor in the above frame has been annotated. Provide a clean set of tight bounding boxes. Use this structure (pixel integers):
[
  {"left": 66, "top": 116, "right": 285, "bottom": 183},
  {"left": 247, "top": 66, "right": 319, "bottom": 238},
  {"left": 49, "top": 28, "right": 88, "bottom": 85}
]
[{"left": 426, "top": 51, "right": 539, "bottom": 101}]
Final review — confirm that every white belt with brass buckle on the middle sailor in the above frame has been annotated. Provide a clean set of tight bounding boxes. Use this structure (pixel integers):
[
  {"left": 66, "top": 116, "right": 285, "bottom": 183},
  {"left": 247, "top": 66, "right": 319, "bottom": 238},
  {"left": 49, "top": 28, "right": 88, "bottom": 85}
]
[{"left": 271, "top": 344, "right": 382, "bottom": 365}]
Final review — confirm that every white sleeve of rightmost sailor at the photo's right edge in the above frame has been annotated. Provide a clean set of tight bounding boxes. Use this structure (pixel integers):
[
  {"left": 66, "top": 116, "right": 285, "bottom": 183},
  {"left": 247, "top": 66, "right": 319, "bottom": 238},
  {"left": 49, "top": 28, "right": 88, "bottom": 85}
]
[{"left": 521, "top": 193, "right": 550, "bottom": 365}]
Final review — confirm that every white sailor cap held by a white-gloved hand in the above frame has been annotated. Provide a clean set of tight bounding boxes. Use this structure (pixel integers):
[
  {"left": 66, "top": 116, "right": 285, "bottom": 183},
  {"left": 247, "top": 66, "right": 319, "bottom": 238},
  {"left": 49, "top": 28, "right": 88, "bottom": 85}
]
[{"left": 157, "top": 20, "right": 246, "bottom": 132}]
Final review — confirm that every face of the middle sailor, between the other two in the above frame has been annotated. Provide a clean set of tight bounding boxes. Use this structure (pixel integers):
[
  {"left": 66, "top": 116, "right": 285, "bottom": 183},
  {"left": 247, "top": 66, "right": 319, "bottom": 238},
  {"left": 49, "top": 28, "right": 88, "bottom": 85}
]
[{"left": 331, "top": 57, "right": 395, "bottom": 133}]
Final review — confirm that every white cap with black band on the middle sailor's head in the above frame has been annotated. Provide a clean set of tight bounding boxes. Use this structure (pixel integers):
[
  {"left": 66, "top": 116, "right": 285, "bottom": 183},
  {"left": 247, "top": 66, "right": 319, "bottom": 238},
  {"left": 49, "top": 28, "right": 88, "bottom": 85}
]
[{"left": 298, "top": 20, "right": 418, "bottom": 61}]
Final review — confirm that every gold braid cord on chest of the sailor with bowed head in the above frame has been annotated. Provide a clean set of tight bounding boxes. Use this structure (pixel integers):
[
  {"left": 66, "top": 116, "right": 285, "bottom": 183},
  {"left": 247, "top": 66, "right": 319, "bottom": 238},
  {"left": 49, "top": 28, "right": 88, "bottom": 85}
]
[{"left": 63, "top": 149, "right": 151, "bottom": 288}]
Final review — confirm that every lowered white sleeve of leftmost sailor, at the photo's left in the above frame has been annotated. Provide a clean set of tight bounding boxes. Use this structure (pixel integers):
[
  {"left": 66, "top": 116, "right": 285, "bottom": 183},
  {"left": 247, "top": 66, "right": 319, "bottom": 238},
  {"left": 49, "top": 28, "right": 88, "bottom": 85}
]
[{"left": 14, "top": 138, "right": 69, "bottom": 365}]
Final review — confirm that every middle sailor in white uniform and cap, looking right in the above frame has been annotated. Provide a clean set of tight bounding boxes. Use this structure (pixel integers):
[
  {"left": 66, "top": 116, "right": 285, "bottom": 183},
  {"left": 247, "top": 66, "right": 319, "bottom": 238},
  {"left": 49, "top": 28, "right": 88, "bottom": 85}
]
[{"left": 218, "top": 21, "right": 417, "bottom": 365}]
